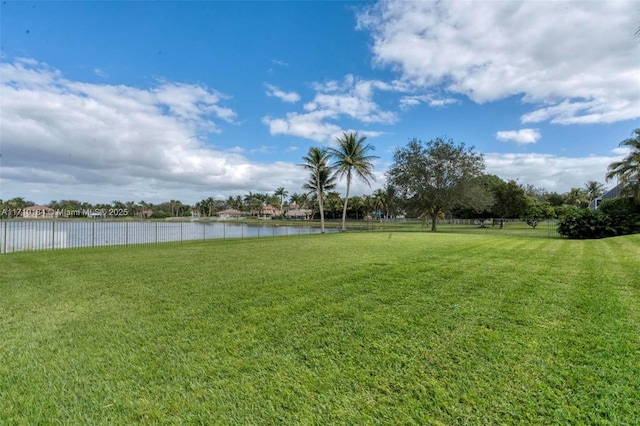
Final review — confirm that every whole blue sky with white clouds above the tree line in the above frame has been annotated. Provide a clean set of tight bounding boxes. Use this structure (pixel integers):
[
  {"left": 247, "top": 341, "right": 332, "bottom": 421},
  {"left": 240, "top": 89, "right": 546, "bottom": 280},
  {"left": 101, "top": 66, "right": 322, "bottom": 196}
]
[{"left": 0, "top": 1, "right": 640, "bottom": 203}]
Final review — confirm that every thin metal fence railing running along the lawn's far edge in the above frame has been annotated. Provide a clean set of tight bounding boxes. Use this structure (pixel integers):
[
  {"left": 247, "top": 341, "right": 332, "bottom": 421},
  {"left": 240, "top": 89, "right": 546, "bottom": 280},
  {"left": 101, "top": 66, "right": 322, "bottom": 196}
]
[{"left": 0, "top": 219, "right": 559, "bottom": 253}]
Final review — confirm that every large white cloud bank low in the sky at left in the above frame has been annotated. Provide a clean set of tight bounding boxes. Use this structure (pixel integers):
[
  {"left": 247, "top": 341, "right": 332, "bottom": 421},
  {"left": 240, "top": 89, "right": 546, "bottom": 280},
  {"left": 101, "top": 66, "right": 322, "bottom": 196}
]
[{"left": 0, "top": 61, "right": 303, "bottom": 203}]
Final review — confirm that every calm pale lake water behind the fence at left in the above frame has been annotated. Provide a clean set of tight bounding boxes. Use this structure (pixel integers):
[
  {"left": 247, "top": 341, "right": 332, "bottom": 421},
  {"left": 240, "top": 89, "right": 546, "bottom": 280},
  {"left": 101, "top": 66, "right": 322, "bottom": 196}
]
[{"left": 0, "top": 220, "right": 336, "bottom": 253}]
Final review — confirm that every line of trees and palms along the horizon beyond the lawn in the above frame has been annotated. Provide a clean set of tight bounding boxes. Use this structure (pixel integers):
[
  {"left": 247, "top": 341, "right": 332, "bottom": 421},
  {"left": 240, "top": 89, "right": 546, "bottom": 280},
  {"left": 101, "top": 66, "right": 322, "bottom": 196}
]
[{"left": 0, "top": 129, "right": 640, "bottom": 237}]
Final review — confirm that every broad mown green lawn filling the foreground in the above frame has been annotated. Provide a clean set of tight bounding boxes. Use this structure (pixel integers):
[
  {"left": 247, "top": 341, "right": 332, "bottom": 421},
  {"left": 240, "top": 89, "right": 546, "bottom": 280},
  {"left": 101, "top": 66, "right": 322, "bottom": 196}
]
[{"left": 0, "top": 232, "right": 640, "bottom": 425}]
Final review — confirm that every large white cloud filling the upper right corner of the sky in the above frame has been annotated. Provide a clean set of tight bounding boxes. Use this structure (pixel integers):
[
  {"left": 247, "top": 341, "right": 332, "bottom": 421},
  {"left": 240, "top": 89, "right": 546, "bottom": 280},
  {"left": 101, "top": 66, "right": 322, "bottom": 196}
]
[{"left": 358, "top": 1, "right": 640, "bottom": 124}]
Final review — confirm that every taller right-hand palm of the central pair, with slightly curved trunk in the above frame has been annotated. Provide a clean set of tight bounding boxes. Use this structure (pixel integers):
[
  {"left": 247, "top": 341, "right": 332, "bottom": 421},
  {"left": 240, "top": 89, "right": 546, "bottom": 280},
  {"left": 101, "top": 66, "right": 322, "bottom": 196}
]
[{"left": 328, "top": 132, "right": 378, "bottom": 232}]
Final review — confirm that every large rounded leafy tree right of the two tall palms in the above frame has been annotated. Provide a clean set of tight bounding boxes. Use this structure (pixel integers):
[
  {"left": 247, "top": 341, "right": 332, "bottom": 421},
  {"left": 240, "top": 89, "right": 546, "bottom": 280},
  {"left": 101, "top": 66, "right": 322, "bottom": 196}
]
[{"left": 387, "top": 138, "right": 490, "bottom": 231}]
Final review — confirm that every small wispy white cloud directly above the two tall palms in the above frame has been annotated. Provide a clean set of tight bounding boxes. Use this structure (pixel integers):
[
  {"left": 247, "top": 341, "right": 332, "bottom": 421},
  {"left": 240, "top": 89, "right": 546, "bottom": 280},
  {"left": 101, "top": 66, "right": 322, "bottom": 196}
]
[{"left": 262, "top": 75, "right": 397, "bottom": 142}]
